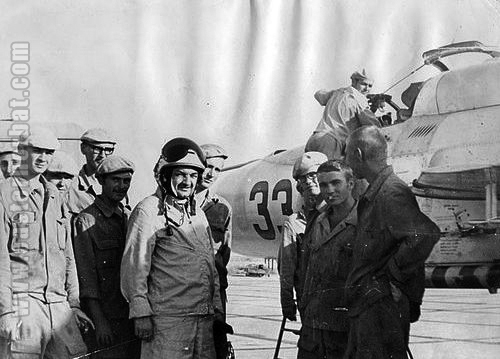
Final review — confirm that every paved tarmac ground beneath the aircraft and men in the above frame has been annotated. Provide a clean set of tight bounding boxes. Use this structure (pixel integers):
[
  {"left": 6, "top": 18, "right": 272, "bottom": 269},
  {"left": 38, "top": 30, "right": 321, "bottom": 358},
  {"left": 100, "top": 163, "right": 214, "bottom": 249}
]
[{"left": 227, "top": 274, "right": 500, "bottom": 359}]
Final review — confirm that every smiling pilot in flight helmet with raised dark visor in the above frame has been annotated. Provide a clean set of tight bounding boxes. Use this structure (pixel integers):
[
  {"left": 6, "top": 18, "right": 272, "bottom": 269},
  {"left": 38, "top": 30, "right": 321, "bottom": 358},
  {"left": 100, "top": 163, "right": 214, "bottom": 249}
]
[{"left": 121, "top": 138, "right": 222, "bottom": 359}]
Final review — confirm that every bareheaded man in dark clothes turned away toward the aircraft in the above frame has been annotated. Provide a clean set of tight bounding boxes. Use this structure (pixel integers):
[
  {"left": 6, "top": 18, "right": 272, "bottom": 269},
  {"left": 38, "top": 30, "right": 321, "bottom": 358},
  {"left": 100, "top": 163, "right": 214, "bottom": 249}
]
[{"left": 346, "top": 126, "right": 440, "bottom": 359}]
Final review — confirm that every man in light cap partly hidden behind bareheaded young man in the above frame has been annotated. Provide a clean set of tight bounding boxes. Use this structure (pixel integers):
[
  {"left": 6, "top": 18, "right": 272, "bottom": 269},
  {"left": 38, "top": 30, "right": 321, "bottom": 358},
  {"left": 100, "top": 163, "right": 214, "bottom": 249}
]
[{"left": 278, "top": 152, "right": 328, "bottom": 321}]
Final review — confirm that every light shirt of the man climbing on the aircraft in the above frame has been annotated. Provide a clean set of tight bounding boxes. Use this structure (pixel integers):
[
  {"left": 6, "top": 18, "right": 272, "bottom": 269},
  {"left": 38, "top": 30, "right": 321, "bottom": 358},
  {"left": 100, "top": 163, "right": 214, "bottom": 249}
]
[{"left": 314, "top": 86, "right": 380, "bottom": 139}]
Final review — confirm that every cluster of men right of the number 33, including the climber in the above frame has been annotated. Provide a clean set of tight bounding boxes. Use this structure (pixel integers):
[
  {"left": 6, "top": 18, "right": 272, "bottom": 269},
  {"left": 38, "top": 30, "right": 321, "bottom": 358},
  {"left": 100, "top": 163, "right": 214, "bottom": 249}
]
[{"left": 278, "top": 71, "right": 440, "bottom": 359}]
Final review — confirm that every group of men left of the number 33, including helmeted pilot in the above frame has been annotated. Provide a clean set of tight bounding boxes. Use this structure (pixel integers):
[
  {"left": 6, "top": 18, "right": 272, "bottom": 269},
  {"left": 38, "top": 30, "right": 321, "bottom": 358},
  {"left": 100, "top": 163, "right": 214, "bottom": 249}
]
[{"left": 0, "top": 127, "right": 232, "bottom": 359}]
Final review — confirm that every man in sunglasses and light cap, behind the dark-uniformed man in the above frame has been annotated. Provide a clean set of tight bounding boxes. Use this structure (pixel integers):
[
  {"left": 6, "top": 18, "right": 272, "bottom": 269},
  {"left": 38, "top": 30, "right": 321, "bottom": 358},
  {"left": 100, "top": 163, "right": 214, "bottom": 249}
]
[{"left": 67, "top": 128, "right": 116, "bottom": 216}]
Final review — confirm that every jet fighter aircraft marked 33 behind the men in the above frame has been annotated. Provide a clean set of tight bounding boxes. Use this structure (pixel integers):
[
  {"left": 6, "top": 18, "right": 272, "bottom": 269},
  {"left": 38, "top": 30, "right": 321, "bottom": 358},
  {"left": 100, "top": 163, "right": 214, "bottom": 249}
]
[{"left": 214, "top": 41, "right": 500, "bottom": 293}]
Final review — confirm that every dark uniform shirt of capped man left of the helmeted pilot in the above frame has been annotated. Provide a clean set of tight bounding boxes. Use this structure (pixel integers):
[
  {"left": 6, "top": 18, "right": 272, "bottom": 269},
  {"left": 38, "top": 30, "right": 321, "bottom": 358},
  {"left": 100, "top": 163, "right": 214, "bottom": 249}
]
[{"left": 74, "top": 195, "right": 129, "bottom": 319}]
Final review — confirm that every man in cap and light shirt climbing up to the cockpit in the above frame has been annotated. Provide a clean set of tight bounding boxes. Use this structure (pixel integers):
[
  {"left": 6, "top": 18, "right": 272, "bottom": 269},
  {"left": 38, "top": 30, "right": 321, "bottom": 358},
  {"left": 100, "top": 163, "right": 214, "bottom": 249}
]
[{"left": 305, "top": 69, "right": 380, "bottom": 159}]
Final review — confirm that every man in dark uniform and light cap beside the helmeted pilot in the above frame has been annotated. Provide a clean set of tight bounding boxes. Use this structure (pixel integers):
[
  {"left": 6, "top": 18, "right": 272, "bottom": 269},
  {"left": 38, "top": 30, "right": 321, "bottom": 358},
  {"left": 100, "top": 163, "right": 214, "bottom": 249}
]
[{"left": 74, "top": 156, "right": 140, "bottom": 359}]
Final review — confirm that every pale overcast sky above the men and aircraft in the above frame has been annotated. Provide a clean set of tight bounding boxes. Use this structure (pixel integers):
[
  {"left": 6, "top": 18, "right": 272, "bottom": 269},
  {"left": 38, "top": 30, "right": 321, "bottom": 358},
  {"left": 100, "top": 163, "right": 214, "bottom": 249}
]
[{"left": 0, "top": 0, "right": 500, "bottom": 199}]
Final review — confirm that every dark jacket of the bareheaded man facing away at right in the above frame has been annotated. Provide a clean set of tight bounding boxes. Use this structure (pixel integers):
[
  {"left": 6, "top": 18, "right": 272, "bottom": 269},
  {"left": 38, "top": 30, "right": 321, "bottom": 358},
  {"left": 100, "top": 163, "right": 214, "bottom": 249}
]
[{"left": 347, "top": 166, "right": 440, "bottom": 315}]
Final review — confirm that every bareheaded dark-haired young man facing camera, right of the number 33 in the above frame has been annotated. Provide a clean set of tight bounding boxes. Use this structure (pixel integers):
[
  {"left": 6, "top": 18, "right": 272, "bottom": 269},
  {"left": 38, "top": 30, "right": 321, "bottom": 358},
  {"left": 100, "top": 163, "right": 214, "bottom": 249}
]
[{"left": 297, "top": 160, "right": 357, "bottom": 359}]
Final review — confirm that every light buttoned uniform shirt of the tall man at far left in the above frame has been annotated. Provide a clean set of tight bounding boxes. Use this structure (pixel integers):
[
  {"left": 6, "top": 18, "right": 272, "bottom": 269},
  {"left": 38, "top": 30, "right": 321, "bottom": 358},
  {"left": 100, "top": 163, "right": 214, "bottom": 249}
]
[{"left": 0, "top": 176, "right": 79, "bottom": 315}]
